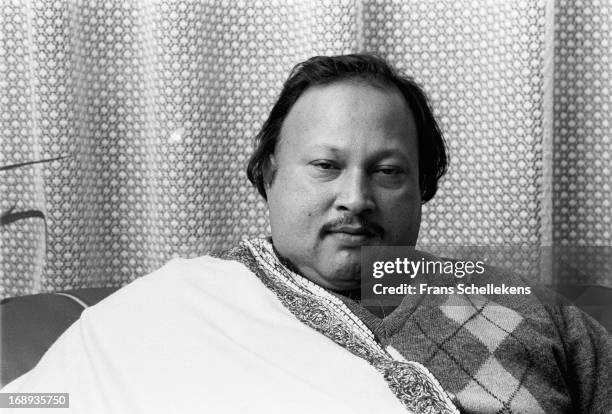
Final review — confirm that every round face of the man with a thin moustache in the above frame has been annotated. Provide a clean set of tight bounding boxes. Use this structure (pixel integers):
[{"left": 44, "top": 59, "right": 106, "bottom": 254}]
[{"left": 266, "top": 81, "right": 421, "bottom": 290}]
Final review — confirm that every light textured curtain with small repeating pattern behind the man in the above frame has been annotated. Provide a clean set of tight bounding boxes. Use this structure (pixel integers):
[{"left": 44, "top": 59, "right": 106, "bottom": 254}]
[{"left": 0, "top": 0, "right": 612, "bottom": 296}]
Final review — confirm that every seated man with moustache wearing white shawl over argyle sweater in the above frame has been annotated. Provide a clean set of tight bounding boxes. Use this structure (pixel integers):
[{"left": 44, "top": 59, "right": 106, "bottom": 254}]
[{"left": 3, "top": 55, "right": 612, "bottom": 413}]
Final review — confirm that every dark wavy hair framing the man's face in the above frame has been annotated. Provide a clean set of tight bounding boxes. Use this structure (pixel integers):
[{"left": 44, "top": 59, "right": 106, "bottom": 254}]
[{"left": 247, "top": 54, "right": 448, "bottom": 203}]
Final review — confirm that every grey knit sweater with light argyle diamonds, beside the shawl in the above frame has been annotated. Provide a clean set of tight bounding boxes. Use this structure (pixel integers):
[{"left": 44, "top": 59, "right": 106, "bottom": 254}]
[{"left": 338, "top": 271, "right": 612, "bottom": 414}]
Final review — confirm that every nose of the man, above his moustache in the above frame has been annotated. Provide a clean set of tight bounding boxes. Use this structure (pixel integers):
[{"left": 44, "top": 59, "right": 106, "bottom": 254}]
[{"left": 336, "top": 170, "right": 376, "bottom": 215}]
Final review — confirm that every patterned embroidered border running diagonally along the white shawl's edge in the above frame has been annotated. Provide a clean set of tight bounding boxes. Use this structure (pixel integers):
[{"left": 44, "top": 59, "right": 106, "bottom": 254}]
[{"left": 237, "top": 239, "right": 459, "bottom": 414}]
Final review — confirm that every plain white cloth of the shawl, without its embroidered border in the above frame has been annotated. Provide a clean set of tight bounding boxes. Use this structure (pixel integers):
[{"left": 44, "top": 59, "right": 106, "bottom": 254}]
[{"left": 2, "top": 257, "right": 406, "bottom": 414}]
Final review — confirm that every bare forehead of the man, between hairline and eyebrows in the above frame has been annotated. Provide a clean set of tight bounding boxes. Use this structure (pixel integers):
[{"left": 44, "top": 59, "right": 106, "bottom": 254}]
[{"left": 279, "top": 80, "right": 416, "bottom": 157}]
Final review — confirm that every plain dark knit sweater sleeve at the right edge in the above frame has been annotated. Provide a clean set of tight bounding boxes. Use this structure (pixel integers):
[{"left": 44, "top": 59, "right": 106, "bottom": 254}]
[{"left": 559, "top": 305, "right": 612, "bottom": 413}]
